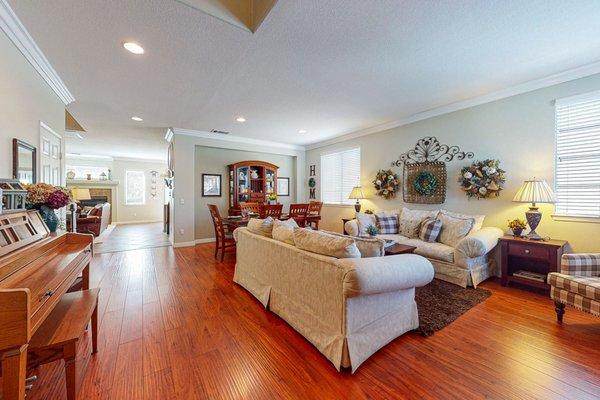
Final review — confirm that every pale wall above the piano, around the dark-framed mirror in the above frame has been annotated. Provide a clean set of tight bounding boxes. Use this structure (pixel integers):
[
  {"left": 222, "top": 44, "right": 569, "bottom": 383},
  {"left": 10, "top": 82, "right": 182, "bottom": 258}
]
[{"left": 0, "top": 31, "right": 65, "bottom": 180}]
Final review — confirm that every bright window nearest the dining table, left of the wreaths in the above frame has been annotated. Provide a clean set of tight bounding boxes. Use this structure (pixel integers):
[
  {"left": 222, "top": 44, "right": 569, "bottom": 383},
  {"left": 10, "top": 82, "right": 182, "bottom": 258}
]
[{"left": 321, "top": 148, "right": 360, "bottom": 204}]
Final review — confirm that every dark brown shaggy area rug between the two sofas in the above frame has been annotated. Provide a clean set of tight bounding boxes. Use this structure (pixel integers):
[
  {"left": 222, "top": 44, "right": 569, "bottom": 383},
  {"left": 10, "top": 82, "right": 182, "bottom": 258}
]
[{"left": 415, "top": 279, "right": 491, "bottom": 336}]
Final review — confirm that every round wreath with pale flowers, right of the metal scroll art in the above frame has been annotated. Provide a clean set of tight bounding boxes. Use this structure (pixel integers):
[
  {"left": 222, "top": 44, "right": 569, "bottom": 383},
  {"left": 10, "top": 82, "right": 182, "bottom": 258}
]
[{"left": 458, "top": 159, "right": 506, "bottom": 199}]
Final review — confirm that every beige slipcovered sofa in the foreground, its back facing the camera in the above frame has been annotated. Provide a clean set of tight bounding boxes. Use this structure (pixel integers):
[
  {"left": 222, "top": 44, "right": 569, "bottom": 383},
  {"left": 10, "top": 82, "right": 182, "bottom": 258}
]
[{"left": 234, "top": 228, "right": 434, "bottom": 372}]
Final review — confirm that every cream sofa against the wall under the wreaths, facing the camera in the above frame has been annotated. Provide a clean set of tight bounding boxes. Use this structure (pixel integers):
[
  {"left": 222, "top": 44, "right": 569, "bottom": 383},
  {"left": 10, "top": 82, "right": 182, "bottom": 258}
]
[{"left": 345, "top": 209, "right": 504, "bottom": 287}]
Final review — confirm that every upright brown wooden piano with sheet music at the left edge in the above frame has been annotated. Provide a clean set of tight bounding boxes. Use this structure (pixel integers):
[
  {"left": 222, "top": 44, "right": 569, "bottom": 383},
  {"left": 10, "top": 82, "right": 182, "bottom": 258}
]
[{"left": 0, "top": 211, "right": 93, "bottom": 400}]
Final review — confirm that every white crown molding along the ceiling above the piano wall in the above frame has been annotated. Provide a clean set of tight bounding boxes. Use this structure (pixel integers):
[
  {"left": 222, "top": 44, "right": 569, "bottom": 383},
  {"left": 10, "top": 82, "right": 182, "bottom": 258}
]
[{"left": 0, "top": 0, "right": 75, "bottom": 105}]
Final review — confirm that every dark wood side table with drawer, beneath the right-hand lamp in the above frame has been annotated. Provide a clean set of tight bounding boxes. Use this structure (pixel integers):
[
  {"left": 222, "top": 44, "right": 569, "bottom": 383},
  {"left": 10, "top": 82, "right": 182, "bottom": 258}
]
[{"left": 500, "top": 236, "right": 568, "bottom": 289}]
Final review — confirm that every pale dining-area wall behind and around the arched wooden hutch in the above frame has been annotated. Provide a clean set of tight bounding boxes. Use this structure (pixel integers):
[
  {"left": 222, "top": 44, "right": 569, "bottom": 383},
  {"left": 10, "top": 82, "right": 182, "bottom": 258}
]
[{"left": 194, "top": 146, "right": 296, "bottom": 240}]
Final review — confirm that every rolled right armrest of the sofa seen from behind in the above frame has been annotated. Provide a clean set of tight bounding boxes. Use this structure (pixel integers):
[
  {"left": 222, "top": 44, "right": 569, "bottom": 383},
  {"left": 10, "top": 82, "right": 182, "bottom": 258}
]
[{"left": 339, "top": 254, "right": 434, "bottom": 297}]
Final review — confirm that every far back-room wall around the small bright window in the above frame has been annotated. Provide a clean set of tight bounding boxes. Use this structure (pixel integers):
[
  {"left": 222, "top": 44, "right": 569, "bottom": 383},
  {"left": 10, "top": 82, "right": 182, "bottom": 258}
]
[{"left": 67, "top": 156, "right": 167, "bottom": 223}]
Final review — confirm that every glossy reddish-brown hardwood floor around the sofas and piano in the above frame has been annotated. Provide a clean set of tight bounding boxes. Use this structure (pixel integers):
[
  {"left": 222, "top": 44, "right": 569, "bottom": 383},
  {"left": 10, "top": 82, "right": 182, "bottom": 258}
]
[{"left": 18, "top": 244, "right": 600, "bottom": 400}]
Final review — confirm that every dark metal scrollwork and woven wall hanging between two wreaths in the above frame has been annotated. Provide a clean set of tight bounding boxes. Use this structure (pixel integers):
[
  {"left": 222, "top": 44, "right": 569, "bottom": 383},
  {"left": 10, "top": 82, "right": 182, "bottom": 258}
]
[{"left": 392, "top": 136, "right": 474, "bottom": 204}]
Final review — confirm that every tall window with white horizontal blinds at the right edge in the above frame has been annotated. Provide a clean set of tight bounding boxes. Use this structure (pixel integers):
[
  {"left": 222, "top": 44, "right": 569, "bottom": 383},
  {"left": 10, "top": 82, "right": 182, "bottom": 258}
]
[{"left": 555, "top": 92, "right": 600, "bottom": 218}]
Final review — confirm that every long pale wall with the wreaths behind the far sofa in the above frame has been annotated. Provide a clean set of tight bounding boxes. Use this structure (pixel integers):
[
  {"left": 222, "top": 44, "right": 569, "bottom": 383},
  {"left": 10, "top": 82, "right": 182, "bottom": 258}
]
[{"left": 306, "top": 75, "right": 600, "bottom": 251}]
